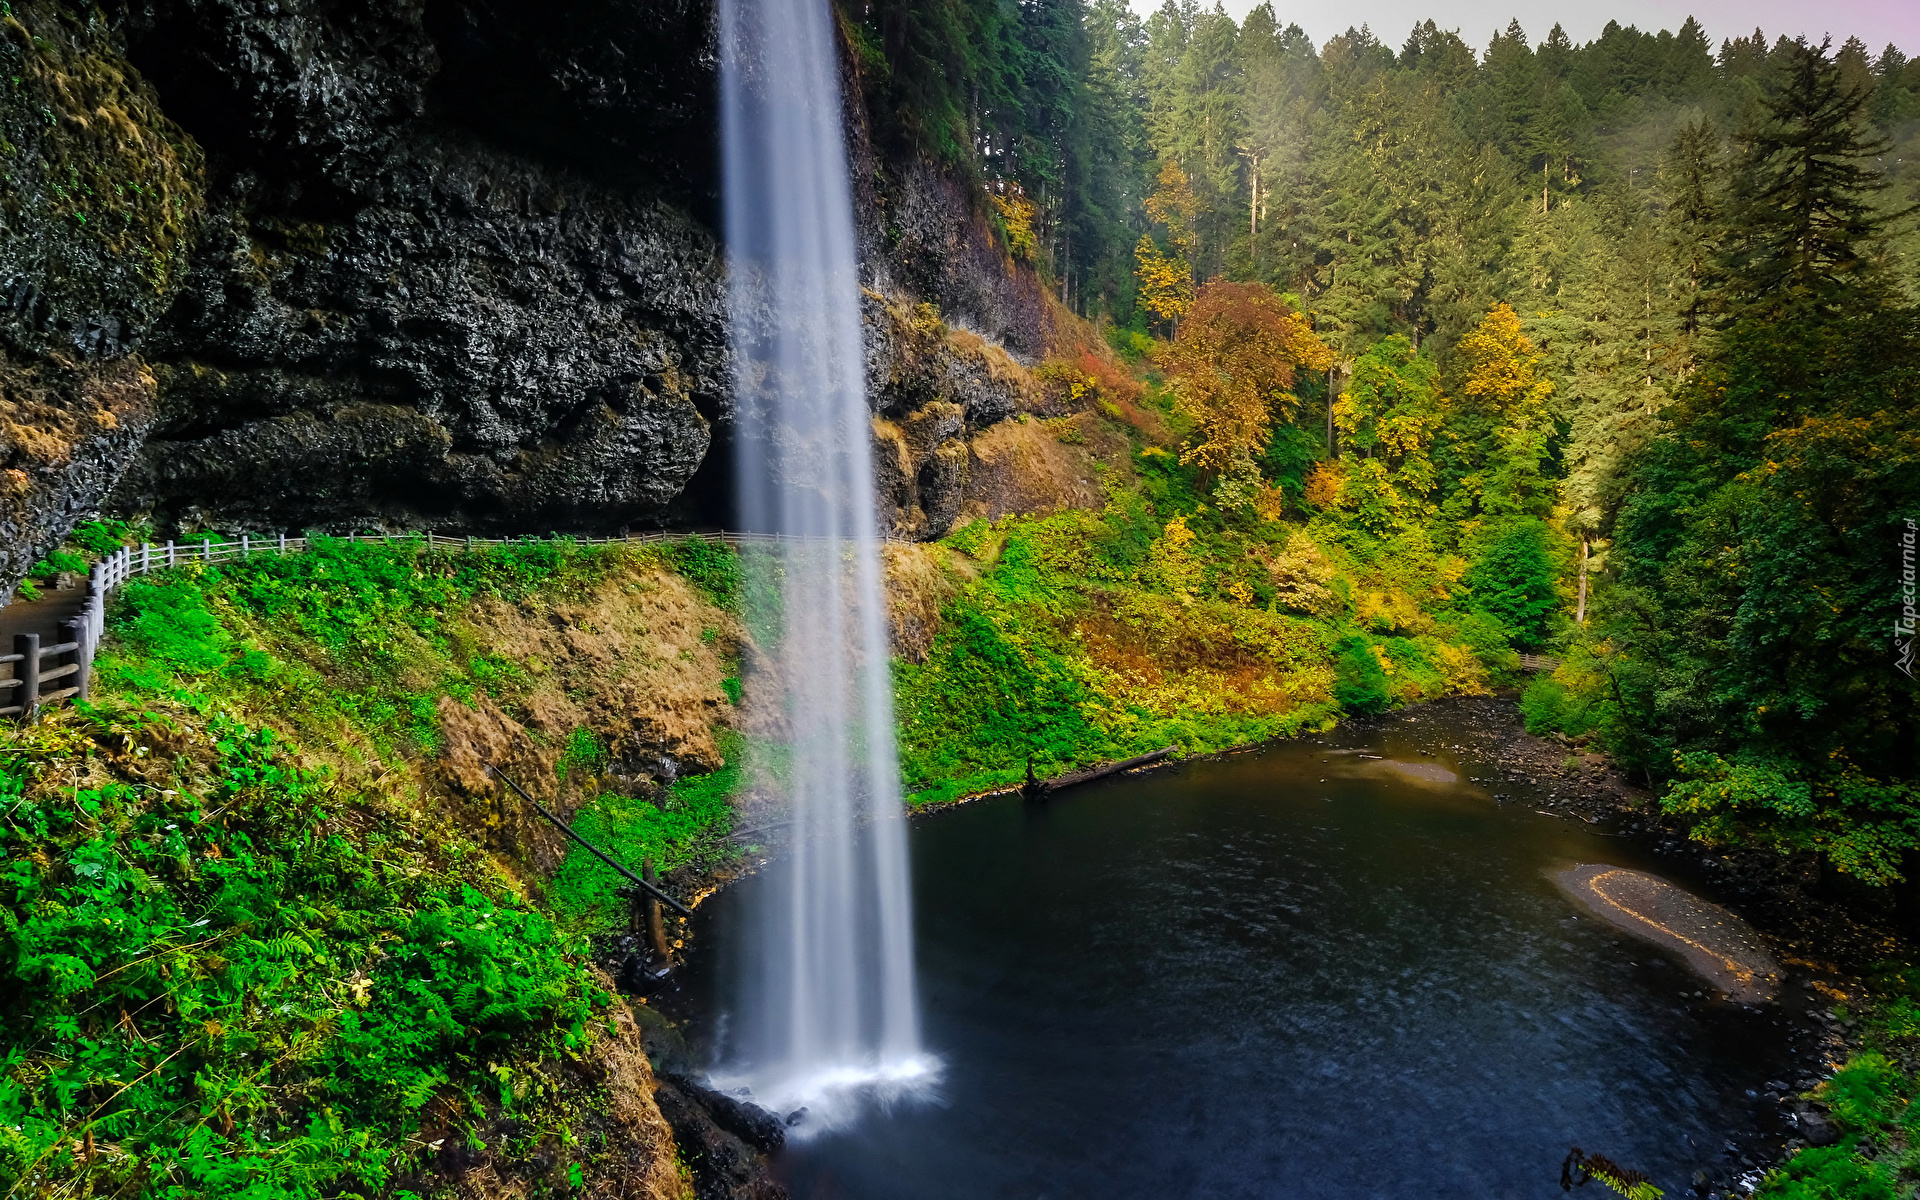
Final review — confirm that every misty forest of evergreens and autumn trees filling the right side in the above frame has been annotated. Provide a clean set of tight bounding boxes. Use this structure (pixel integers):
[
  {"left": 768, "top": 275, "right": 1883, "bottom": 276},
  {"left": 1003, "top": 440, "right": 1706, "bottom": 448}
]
[{"left": 845, "top": 0, "right": 1920, "bottom": 885}]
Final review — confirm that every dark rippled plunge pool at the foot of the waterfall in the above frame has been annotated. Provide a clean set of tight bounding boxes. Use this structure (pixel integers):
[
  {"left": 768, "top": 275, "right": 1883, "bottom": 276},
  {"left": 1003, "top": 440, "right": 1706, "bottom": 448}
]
[{"left": 689, "top": 710, "right": 1799, "bottom": 1200}]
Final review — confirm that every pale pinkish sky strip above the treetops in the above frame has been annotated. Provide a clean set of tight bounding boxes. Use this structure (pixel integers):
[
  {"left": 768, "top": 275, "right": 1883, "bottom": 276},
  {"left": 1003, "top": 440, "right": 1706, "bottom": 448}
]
[{"left": 1131, "top": 0, "right": 1920, "bottom": 56}]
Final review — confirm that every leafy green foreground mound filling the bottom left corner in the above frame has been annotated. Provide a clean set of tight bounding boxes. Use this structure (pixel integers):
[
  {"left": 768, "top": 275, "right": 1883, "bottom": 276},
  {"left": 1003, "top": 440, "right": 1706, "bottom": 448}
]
[{"left": 0, "top": 701, "right": 607, "bottom": 1200}]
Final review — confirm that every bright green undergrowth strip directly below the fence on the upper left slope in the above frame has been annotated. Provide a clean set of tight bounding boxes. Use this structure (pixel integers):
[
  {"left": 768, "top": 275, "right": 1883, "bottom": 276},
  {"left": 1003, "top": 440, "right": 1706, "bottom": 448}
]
[{"left": 98, "top": 538, "right": 629, "bottom": 756}]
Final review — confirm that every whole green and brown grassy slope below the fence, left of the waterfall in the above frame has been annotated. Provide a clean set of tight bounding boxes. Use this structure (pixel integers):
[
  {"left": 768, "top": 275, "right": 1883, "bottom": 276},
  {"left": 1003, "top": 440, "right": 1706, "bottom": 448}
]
[{"left": 0, "top": 543, "right": 732, "bottom": 1196}]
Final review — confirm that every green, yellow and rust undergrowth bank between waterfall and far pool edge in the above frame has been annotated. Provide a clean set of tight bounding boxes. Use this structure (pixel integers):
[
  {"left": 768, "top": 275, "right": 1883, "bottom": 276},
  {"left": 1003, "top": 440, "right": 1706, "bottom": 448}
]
[{"left": 895, "top": 435, "right": 1553, "bottom": 804}]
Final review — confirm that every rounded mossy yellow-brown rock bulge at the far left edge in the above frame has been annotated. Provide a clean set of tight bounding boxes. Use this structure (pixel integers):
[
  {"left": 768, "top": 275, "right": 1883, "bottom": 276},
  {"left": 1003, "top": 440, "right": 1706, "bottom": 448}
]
[{"left": 0, "top": 4, "right": 204, "bottom": 588}]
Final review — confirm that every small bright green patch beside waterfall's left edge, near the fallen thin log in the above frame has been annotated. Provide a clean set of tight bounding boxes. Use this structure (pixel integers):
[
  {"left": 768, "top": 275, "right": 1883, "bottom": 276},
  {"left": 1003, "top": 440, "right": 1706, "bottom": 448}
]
[{"left": 547, "top": 733, "right": 745, "bottom": 931}]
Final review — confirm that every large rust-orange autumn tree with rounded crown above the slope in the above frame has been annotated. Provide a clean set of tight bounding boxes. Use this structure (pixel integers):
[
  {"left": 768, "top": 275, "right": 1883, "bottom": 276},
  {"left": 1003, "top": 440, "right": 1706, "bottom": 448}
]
[{"left": 1160, "top": 280, "right": 1332, "bottom": 495}]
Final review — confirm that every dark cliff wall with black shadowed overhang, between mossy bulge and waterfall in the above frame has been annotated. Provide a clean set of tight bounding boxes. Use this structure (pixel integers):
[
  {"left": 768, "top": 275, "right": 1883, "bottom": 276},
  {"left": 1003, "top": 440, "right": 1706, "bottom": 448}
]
[{"left": 115, "top": 0, "right": 726, "bottom": 530}]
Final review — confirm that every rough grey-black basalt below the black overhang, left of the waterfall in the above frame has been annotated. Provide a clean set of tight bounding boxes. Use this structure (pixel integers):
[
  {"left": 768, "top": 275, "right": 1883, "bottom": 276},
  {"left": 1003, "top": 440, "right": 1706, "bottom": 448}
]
[{"left": 115, "top": 136, "right": 728, "bottom": 530}]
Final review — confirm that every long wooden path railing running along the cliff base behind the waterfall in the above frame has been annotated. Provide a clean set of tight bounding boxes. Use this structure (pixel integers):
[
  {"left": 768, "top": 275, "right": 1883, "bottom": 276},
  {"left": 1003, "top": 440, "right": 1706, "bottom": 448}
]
[{"left": 11, "top": 530, "right": 799, "bottom": 720}]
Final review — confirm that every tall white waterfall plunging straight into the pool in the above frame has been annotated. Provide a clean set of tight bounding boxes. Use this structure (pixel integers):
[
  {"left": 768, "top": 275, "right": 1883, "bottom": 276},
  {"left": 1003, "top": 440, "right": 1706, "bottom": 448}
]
[{"left": 720, "top": 0, "right": 927, "bottom": 1116}]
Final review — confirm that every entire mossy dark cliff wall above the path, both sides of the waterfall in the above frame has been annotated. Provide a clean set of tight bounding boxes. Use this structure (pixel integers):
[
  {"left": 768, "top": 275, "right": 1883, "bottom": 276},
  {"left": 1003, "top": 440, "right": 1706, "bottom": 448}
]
[{"left": 0, "top": 0, "right": 1060, "bottom": 584}]
